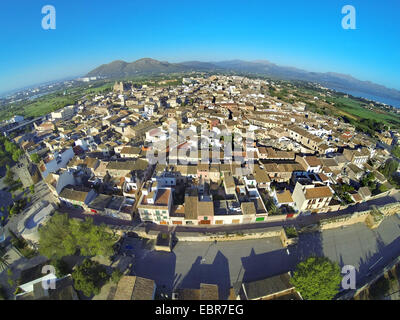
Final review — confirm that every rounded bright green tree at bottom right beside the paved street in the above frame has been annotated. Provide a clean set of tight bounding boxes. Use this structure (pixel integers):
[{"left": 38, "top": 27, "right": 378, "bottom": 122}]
[{"left": 291, "top": 257, "right": 342, "bottom": 300}]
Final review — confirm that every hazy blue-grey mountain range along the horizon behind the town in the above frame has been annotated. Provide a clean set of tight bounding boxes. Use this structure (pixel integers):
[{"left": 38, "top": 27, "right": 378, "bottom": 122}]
[{"left": 87, "top": 58, "right": 400, "bottom": 100}]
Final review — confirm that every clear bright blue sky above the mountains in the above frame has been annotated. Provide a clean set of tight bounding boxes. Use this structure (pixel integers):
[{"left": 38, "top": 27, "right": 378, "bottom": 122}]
[{"left": 0, "top": 0, "right": 400, "bottom": 92}]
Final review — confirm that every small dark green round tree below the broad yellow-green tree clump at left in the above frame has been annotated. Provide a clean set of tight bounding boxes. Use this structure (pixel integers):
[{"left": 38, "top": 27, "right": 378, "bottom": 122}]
[{"left": 72, "top": 259, "right": 108, "bottom": 297}]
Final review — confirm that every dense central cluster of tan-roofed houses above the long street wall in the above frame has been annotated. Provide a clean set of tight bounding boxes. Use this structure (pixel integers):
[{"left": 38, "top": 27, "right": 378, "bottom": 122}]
[{"left": 6, "top": 76, "right": 393, "bottom": 225}]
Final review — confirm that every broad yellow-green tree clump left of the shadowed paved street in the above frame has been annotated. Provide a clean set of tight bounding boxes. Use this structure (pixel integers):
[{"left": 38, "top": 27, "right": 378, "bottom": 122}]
[{"left": 39, "top": 213, "right": 117, "bottom": 258}]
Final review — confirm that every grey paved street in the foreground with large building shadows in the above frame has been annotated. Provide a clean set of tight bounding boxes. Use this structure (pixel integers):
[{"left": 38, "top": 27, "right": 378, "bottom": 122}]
[{"left": 122, "top": 216, "right": 400, "bottom": 297}]
